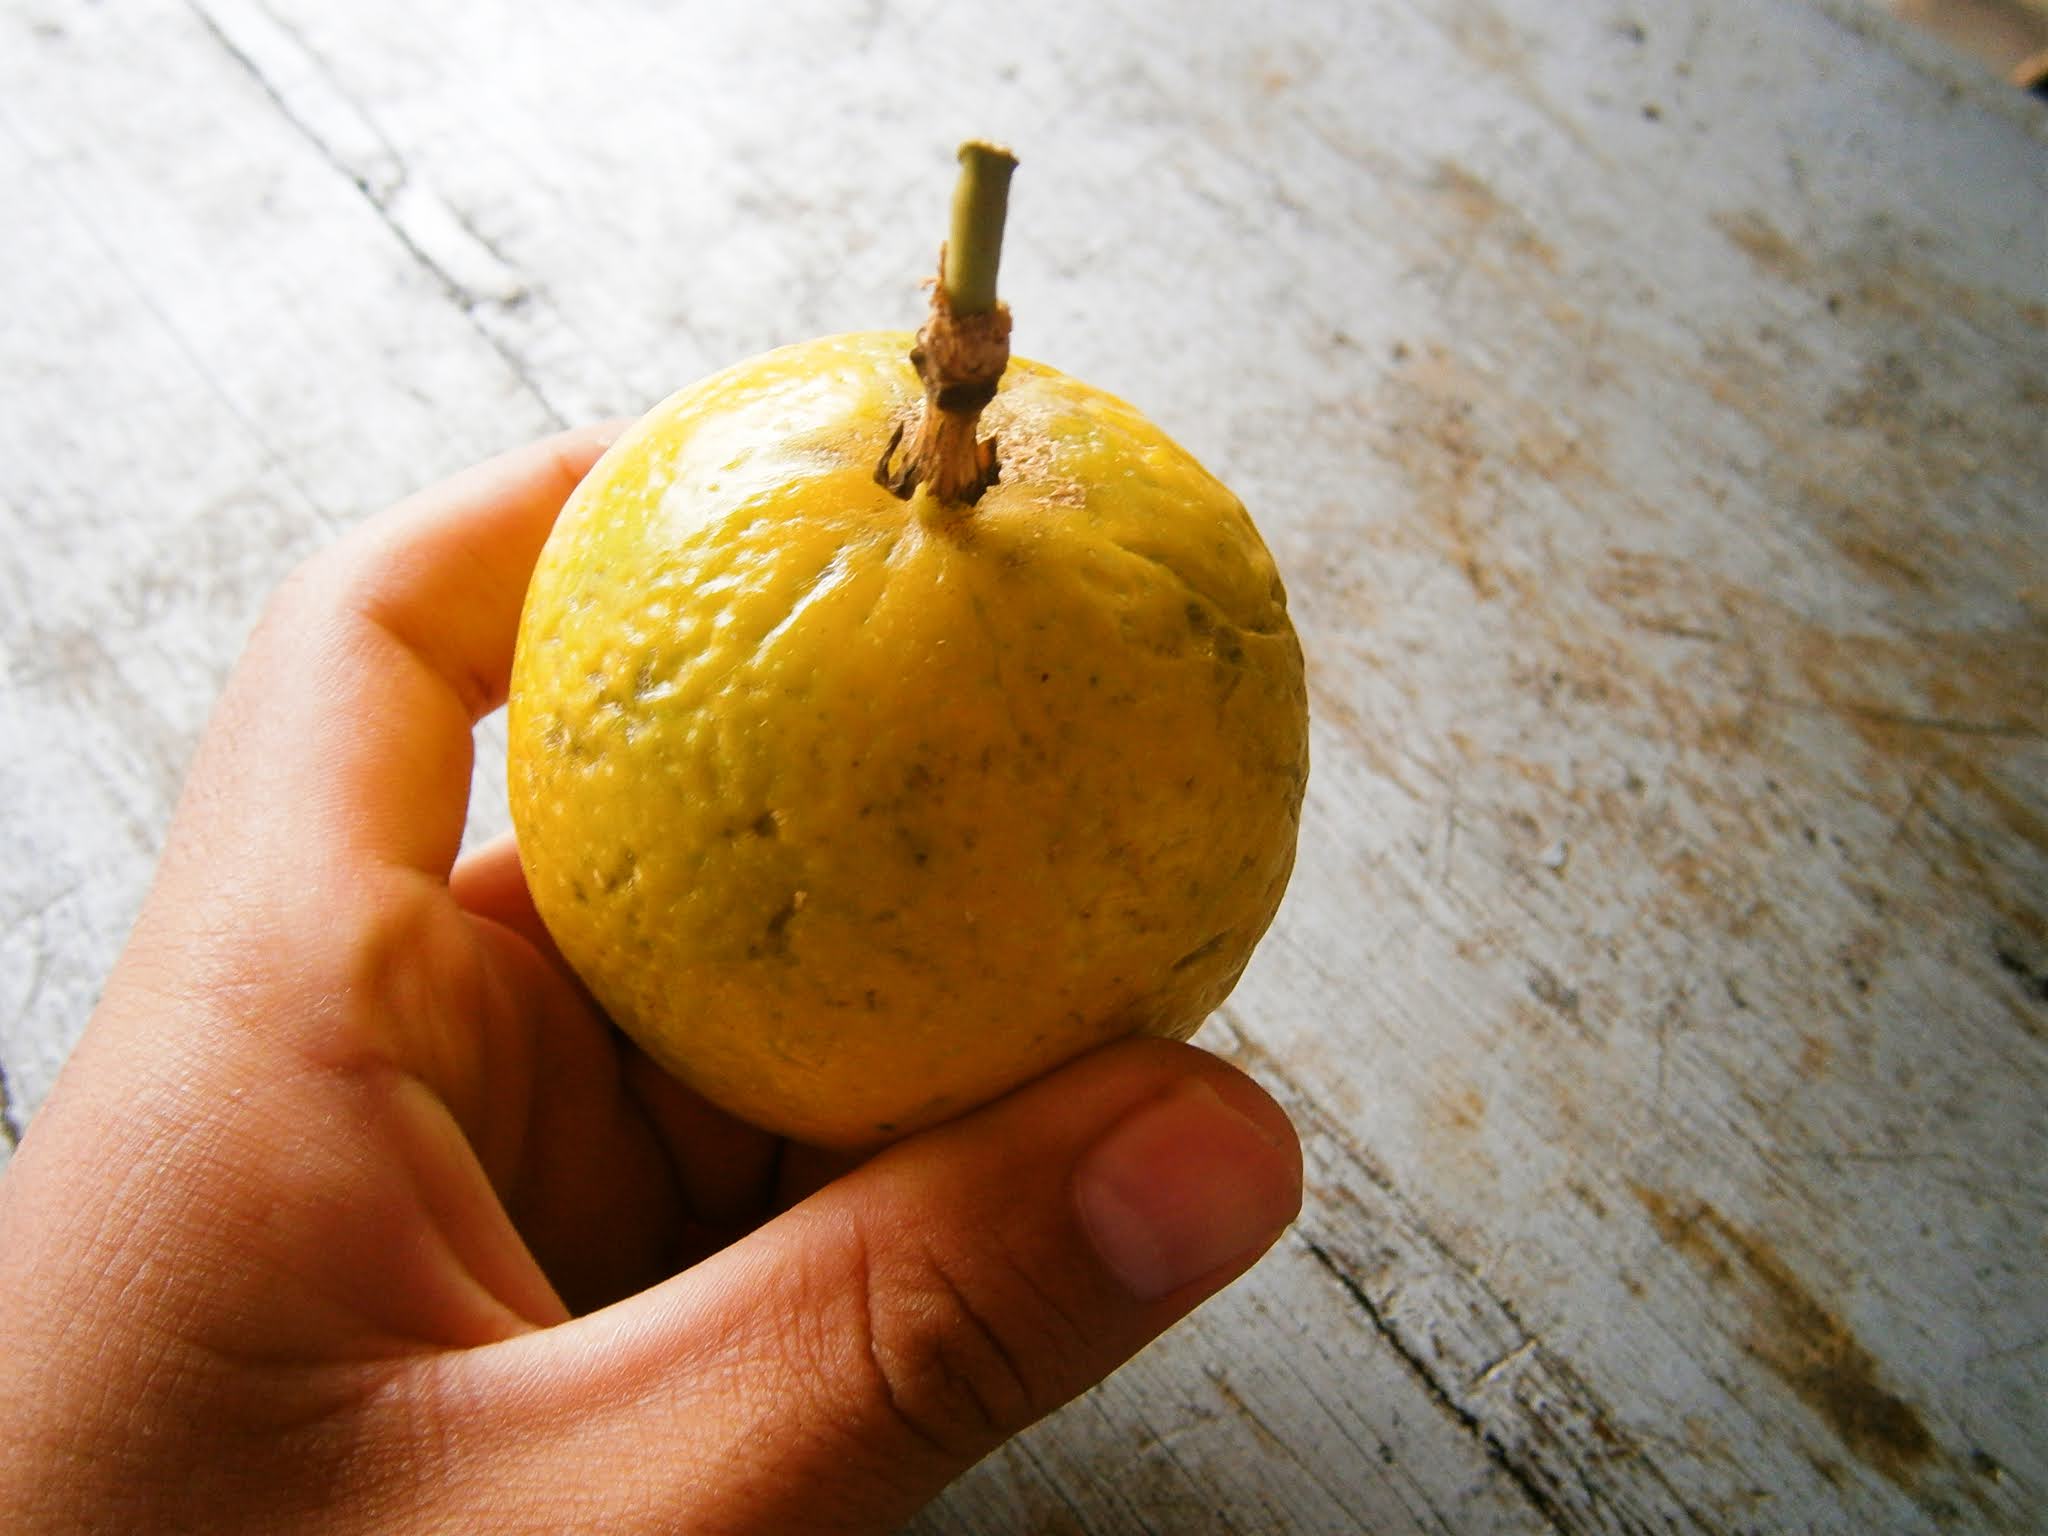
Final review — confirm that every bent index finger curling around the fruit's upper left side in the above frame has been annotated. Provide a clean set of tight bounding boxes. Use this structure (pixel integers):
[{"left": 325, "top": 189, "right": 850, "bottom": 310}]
[{"left": 172, "top": 426, "right": 618, "bottom": 897}]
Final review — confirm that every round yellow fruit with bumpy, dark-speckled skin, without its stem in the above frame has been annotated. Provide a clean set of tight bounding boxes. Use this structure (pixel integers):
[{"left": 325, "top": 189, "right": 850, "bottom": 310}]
[{"left": 508, "top": 332, "right": 1309, "bottom": 1147}]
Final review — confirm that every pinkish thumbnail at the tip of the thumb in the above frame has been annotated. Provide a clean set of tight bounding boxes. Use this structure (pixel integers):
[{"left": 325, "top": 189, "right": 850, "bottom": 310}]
[{"left": 1073, "top": 1077, "right": 1300, "bottom": 1300}]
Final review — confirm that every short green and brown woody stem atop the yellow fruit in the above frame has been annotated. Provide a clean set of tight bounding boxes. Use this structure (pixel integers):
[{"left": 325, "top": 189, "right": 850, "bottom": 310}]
[{"left": 874, "top": 139, "right": 1018, "bottom": 508}]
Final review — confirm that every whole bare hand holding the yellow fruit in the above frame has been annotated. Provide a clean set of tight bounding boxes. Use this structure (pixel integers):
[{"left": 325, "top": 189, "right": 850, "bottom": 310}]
[{"left": 0, "top": 432, "right": 1300, "bottom": 1536}]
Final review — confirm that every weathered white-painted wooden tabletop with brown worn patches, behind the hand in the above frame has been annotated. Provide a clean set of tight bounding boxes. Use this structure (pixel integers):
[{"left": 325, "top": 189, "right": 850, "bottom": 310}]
[{"left": 0, "top": 0, "right": 2048, "bottom": 1536}]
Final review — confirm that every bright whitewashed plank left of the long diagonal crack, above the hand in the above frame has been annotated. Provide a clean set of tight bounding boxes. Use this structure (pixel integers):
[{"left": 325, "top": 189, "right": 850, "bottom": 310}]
[{"left": 0, "top": 4, "right": 569, "bottom": 1151}]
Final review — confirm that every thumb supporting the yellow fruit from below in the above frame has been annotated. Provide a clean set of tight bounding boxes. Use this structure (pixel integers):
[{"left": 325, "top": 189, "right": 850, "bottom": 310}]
[{"left": 436, "top": 1040, "right": 1300, "bottom": 1532}]
